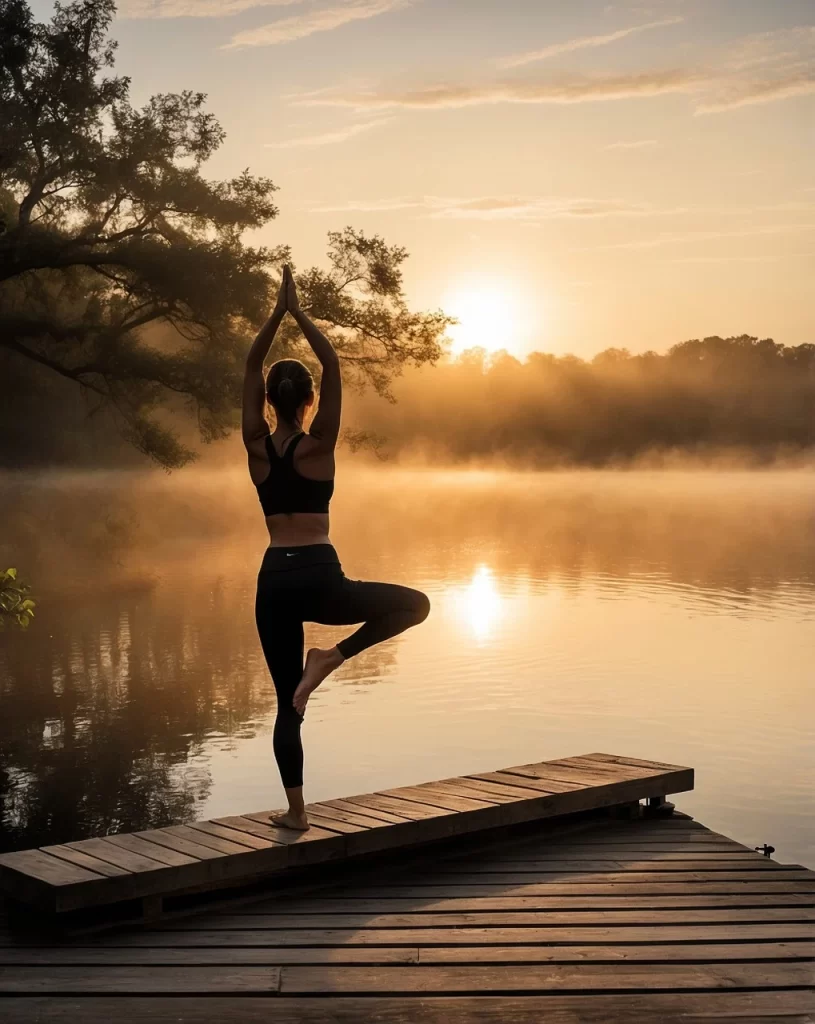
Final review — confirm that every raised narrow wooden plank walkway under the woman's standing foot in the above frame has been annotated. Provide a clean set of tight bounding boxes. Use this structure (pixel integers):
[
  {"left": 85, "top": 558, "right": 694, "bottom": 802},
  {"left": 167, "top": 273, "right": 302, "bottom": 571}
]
[{"left": 0, "top": 754, "right": 693, "bottom": 914}]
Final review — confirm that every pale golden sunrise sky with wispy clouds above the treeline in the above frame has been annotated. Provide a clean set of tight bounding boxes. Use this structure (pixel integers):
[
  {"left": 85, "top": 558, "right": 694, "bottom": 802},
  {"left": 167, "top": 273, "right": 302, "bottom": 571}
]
[{"left": 33, "top": 0, "right": 815, "bottom": 358}]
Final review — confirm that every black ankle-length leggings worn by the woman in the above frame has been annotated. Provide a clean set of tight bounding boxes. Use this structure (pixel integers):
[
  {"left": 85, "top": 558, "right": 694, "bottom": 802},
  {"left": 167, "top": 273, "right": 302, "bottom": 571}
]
[{"left": 255, "top": 544, "right": 430, "bottom": 790}]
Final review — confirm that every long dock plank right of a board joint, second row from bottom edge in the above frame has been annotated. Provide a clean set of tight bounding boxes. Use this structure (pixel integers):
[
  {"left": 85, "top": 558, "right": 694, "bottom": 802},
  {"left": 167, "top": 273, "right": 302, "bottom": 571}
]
[{"left": 281, "top": 964, "right": 812, "bottom": 995}]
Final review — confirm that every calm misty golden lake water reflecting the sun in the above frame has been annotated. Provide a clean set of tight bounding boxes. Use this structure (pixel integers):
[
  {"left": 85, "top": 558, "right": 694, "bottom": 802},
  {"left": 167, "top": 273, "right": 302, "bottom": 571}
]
[{"left": 0, "top": 467, "right": 815, "bottom": 865}]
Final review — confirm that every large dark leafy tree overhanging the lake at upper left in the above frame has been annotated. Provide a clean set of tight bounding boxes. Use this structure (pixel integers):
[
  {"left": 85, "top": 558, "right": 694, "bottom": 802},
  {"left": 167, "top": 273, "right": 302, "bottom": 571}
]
[{"left": 0, "top": 0, "right": 449, "bottom": 467}]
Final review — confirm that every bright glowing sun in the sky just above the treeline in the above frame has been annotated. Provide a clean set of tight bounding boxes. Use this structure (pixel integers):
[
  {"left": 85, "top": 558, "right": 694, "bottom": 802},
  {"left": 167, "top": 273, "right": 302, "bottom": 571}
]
[{"left": 442, "top": 276, "right": 521, "bottom": 355}]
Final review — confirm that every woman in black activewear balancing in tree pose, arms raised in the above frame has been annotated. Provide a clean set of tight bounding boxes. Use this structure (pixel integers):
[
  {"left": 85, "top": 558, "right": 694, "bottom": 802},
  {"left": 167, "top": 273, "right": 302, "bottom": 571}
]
[{"left": 243, "top": 266, "right": 430, "bottom": 829}]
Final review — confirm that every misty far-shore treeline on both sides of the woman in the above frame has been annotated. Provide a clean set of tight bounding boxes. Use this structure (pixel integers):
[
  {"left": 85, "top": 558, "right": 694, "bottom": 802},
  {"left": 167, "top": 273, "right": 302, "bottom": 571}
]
[{"left": 0, "top": 336, "right": 815, "bottom": 468}]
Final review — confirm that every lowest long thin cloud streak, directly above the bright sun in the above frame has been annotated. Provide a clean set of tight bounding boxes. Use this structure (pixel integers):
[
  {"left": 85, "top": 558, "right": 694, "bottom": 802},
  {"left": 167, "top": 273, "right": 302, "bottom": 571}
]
[{"left": 310, "top": 196, "right": 683, "bottom": 220}]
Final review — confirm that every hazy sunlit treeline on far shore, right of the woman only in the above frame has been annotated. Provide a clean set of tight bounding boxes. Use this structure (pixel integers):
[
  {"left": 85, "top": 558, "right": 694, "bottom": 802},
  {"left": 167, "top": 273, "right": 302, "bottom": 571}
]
[{"left": 353, "top": 335, "right": 815, "bottom": 466}]
